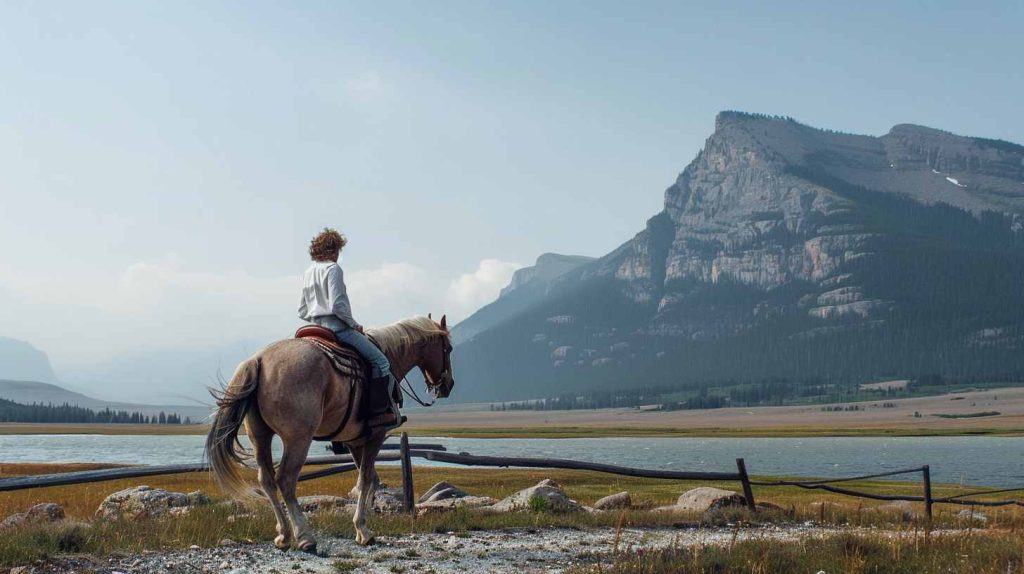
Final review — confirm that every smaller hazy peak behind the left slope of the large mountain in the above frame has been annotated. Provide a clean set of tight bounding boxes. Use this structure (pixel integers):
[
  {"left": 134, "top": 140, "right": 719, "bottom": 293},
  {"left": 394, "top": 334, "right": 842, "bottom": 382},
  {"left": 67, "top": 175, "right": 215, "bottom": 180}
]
[{"left": 452, "top": 253, "right": 594, "bottom": 343}]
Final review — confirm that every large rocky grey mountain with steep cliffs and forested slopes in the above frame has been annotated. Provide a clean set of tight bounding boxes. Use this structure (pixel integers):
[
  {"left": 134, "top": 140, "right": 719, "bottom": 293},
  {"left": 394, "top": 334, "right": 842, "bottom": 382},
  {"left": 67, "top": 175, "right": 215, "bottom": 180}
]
[{"left": 454, "top": 112, "right": 1024, "bottom": 400}]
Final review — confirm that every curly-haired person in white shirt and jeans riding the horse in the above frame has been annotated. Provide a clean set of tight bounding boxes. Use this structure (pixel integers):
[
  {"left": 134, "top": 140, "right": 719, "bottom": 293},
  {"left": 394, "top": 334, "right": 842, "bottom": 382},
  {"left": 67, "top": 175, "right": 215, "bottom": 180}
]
[{"left": 299, "top": 228, "right": 402, "bottom": 431}]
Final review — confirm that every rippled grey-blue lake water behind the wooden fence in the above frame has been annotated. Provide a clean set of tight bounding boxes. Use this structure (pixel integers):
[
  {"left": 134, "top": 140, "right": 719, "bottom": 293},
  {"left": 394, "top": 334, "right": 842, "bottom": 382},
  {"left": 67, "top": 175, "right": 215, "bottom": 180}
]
[{"left": 0, "top": 435, "right": 1024, "bottom": 487}]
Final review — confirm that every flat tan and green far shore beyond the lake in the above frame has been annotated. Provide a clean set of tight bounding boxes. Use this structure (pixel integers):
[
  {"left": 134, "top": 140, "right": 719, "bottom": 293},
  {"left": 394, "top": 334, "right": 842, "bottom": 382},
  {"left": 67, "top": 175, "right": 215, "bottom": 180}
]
[{"left": 0, "top": 387, "right": 1024, "bottom": 439}]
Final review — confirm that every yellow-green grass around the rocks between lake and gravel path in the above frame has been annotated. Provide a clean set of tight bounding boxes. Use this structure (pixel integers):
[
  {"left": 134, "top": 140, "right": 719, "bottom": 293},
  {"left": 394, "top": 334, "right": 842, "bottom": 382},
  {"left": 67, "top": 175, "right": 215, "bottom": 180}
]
[{"left": 0, "top": 465, "right": 1024, "bottom": 572}]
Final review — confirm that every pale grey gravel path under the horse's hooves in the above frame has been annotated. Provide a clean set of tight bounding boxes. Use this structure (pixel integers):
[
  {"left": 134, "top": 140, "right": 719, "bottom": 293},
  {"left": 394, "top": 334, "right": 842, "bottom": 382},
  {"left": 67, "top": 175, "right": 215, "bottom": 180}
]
[{"left": 34, "top": 526, "right": 827, "bottom": 574}]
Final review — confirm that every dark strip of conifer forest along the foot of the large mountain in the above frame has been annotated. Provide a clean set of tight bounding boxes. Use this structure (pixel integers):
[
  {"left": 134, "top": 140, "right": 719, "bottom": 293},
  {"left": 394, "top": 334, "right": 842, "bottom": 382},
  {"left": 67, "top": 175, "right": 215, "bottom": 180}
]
[{"left": 490, "top": 372, "right": 1024, "bottom": 411}]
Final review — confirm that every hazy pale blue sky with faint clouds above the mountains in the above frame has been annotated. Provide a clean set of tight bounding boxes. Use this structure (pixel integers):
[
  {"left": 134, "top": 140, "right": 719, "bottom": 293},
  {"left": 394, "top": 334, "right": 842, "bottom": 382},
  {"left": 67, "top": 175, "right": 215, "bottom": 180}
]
[{"left": 0, "top": 0, "right": 1024, "bottom": 401}]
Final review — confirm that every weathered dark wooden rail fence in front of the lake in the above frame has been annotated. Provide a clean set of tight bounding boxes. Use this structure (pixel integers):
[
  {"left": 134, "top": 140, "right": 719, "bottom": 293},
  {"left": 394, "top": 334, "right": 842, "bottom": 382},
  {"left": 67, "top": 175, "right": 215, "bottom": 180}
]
[{"left": 0, "top": 433, "right": 1024, "bottom": 520}]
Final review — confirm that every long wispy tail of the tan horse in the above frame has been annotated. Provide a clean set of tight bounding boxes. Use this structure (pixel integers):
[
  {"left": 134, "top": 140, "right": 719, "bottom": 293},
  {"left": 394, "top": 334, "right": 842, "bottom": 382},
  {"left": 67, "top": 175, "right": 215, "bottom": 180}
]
[{"left": 206, "top": 358, "right": 260, "bottom": 498}]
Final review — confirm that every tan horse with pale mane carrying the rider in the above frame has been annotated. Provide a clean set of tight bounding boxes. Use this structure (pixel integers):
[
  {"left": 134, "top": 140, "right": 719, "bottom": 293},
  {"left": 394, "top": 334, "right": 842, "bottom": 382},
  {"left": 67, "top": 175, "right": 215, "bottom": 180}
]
[{"left": 206, "top": 316, "right": 455, "bottom": 553}]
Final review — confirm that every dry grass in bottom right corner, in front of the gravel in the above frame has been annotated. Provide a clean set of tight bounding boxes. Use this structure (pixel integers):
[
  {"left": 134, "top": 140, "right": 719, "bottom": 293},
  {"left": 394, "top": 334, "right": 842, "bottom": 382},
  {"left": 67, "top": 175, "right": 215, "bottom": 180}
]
[{"left": 568, "top": 531, "right": 1024, "bottom": 574}]
